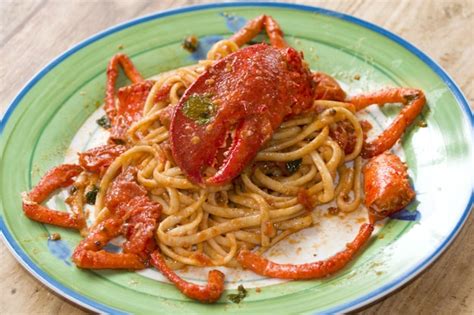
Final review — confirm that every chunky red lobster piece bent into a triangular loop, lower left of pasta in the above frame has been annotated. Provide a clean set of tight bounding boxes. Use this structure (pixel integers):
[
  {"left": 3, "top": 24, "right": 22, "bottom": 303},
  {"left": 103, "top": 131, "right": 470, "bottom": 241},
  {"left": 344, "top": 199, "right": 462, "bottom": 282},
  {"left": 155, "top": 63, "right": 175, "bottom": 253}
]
[{"left": 72, "top": 168, "right": 161, "bottom": 269}]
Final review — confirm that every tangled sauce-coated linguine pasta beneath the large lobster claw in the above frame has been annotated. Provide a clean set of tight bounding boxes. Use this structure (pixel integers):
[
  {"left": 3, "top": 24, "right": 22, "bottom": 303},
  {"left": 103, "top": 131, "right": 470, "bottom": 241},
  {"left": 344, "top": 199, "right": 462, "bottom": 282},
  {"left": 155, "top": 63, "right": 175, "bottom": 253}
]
[{"left": 89, "top": 40, "right": 363, "bottom": 266}]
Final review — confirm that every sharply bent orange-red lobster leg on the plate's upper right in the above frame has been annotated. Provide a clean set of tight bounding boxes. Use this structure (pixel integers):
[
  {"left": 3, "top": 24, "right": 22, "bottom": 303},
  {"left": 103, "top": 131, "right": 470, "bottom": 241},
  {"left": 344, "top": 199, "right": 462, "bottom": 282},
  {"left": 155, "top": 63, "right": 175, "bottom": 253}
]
[{"left": 349, "top": 88, "right": 426, "bottom": 158}]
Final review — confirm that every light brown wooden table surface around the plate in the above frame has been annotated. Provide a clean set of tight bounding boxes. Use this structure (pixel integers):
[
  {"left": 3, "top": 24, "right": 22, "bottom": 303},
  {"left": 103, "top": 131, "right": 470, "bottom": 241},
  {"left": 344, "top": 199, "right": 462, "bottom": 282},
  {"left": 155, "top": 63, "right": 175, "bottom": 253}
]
[{"left": 0, "top": 0, "right": 474, "bottom": 314}]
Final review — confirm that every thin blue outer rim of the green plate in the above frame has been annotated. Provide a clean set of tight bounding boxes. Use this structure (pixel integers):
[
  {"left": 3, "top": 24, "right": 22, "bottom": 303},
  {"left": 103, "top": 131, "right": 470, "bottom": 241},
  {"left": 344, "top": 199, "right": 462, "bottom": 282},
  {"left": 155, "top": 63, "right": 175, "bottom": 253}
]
[{"left": 0, "top": 2, "right": 474, "bottom": 314}]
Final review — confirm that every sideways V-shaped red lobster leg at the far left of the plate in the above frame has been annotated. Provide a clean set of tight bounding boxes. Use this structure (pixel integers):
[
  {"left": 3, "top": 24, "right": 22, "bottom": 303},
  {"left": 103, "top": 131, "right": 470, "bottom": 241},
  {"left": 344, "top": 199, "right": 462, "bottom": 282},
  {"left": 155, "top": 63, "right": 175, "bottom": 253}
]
[{"left": 23, "top": 164, "right": 86, "bottom": 229}]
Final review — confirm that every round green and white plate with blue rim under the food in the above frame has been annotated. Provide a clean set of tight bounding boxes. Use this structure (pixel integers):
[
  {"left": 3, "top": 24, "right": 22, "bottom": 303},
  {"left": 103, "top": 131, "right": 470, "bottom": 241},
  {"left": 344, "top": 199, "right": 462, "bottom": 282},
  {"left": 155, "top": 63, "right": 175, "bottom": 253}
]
[{"left": 0, "top": 2, "right": 474, "bottom": 314}]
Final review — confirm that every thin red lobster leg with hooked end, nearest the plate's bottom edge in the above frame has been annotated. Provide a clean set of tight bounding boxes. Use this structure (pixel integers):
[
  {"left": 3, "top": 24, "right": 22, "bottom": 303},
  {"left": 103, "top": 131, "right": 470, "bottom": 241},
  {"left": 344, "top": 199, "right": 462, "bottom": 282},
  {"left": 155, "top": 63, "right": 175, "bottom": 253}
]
[{"left": 151, "top": 251, "right": 224, "bottom": 303}]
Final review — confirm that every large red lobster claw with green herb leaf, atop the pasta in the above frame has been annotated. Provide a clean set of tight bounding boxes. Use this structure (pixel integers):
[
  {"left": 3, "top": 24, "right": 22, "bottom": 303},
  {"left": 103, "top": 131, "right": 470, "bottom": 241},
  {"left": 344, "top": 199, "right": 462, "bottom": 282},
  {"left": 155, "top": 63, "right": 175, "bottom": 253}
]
[{"left": 170, "top": 44, "right": 312, "bottom": 185}]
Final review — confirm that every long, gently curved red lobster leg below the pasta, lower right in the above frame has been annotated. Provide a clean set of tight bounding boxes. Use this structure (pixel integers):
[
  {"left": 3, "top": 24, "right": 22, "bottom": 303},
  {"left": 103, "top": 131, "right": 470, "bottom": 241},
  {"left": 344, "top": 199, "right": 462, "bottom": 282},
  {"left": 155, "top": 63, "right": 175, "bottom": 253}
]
[{"left": 237, "top": 223, "right": 374, "bottom": 280}]
